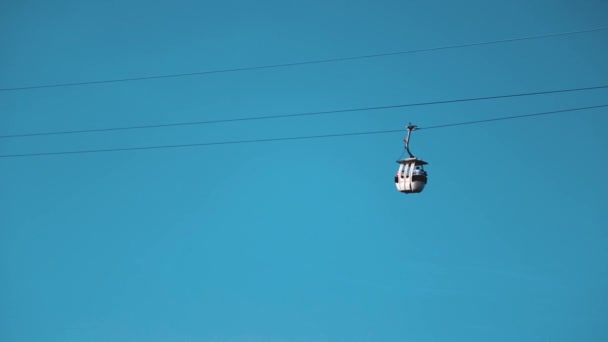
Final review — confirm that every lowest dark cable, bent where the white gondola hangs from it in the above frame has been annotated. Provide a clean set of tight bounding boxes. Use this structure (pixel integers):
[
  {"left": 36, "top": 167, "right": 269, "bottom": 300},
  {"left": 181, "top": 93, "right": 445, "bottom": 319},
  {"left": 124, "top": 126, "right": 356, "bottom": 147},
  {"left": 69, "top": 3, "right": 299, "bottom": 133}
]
[{"left": 0, "top": 104, "right": 608, "bottom": 158}]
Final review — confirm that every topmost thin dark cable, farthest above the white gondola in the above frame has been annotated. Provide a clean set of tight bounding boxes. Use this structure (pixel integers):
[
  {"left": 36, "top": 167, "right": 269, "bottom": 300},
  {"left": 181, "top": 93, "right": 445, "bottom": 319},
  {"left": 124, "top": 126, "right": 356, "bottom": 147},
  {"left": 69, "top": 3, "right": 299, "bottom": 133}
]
[{"left": 0, "top": 27, "right": 608, "bottom": 92}]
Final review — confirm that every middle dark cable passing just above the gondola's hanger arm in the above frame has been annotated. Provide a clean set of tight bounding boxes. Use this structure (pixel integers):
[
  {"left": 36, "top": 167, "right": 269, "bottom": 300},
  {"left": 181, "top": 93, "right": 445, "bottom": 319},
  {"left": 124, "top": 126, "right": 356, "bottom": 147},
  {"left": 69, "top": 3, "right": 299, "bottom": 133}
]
[{"left": 0, "top": 85, "right": 608, "bottom": 139}]
